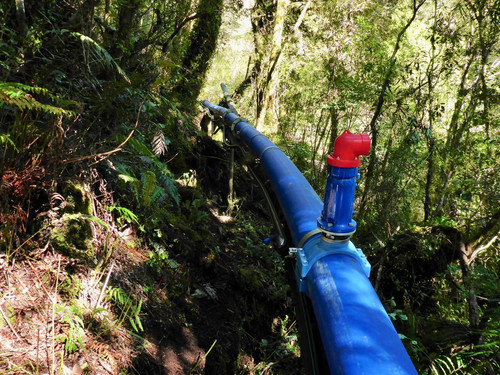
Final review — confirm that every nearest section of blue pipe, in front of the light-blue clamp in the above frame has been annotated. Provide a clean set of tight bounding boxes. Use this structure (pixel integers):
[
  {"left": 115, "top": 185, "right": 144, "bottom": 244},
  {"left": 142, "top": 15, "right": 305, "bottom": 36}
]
[{"left": 307, "top": 254, "right": 417, "bottom": 375}]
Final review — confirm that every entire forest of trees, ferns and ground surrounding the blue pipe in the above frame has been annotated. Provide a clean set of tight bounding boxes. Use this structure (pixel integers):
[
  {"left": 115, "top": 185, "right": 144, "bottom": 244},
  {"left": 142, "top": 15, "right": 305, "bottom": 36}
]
[{"left": 0, "top": 0, "right": 500, "bottom": 374}]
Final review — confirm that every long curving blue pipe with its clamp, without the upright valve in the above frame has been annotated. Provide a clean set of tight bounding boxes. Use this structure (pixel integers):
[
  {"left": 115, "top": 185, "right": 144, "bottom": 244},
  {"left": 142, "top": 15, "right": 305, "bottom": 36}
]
[{"left": 204, "top": 101, "right": 417, "bottom": 375}]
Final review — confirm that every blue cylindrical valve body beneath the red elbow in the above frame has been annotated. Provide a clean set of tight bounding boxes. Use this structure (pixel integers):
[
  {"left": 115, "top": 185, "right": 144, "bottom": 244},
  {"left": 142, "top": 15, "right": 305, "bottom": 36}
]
[{"left": 318, "top": 167, "right": 359, "bottom": 236}]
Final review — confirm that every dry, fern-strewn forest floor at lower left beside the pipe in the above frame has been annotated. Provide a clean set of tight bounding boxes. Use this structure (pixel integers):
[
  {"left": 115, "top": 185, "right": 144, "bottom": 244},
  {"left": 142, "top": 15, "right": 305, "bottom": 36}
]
[{"left": 0, "top": 137, "right": 302, "bottom": 374}]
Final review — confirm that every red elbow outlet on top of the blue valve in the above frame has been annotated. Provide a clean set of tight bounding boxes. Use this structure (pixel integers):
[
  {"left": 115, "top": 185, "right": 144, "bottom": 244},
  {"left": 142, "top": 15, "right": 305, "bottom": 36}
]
[{"left": 326, "top": 130, "right": 371, "bottom": 168}]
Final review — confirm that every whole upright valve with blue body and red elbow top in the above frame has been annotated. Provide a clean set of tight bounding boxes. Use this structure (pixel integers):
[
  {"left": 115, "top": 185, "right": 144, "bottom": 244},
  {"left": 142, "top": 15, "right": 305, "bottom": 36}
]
[{"left": 318, "top": 130, "right": 371, "bottom": 241}]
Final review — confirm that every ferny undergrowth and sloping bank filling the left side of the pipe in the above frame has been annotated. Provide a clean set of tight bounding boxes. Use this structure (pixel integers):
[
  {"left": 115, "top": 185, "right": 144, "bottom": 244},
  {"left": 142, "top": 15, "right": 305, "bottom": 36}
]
[{"left": 0, "top": 0, "right": 298, "bottom": 374}]
